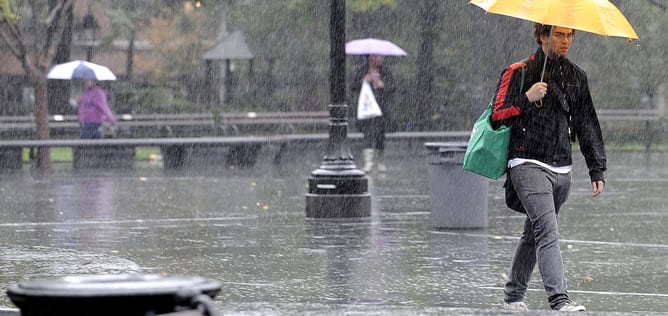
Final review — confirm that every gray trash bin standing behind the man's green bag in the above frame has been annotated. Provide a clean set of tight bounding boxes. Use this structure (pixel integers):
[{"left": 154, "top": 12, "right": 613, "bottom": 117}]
[{"left": 425, "top": 142, "right": 489, "bottom": 228}]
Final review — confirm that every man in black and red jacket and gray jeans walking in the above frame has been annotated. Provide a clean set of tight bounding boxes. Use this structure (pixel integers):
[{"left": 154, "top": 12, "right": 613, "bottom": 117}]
[{"left": 492, "top": 24, "right": 606, "bottom": 311}]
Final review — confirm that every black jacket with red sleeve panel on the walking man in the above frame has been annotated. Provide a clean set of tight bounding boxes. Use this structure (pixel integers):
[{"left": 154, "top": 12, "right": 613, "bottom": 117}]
[{"left": 492, "top": 48, "right": 607, "bottom": 181}]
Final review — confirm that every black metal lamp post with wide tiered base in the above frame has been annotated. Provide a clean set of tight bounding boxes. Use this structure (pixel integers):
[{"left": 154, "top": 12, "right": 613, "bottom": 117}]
[{"left": 306, "top": 0, "right": 371, "bottom": 218}]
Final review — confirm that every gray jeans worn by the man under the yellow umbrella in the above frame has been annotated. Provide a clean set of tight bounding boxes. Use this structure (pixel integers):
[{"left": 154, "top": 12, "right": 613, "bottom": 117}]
[{"left": 504, "top": 163, "right": 571, "bottom": 309}]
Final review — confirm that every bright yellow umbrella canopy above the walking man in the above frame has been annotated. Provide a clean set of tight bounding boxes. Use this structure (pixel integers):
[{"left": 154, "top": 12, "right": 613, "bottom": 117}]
[{"left": 470, "top": 0, "right": 639, "bottom": 39}]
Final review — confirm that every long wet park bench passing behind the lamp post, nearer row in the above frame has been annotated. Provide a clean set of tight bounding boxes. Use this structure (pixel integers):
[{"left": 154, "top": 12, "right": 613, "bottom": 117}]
[{"left": 0, "top": 132, "right": 470, "bottom": 170}]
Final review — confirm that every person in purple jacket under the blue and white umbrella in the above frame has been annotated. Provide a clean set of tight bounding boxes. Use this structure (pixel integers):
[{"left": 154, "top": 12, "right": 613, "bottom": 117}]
[{"left": 78, "top": 79, "right": 116, "bottom": 139}]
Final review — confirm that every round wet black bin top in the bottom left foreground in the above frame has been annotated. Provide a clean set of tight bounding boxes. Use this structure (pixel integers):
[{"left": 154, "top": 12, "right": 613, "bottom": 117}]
[{"left": 7, "top": 274, "right": 221, "bottom": 316}]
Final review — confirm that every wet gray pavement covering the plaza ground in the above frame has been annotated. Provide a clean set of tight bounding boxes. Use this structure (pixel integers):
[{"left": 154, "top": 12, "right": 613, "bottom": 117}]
[{"left": 0, "top": 148, "right": 668, "bottom": 315}]
